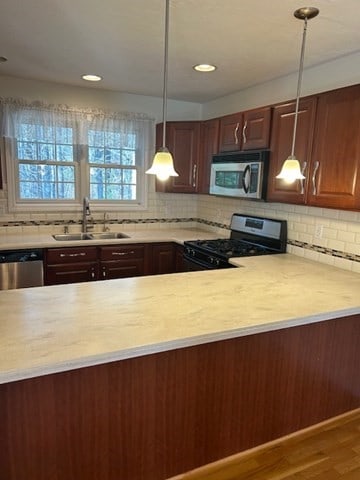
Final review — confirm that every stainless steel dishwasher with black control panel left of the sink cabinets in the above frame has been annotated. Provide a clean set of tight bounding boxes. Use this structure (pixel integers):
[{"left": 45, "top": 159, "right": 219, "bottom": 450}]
[{"left": 0, "top": 248, "right": 44, "bottom": 290}]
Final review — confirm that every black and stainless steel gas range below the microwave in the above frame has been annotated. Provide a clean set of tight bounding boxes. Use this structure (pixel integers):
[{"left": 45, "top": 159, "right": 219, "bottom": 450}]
[{"left": 184, "top": 213, "right": 287, "bottom": 271}]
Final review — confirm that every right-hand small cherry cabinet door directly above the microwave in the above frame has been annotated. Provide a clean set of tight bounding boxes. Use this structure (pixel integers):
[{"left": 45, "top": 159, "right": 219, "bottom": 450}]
[{"left": 241, "top": 107, "right": 271, "bottom": 150}]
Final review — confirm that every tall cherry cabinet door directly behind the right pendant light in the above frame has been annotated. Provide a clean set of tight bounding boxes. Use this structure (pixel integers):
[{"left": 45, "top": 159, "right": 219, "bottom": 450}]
[{"left": 267, "top": 97, "right": 316, "bottom": 204}]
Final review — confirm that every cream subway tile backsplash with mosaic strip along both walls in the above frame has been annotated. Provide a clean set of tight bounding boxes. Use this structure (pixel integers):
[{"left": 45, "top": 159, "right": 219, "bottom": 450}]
[{"left": 0, "top": 186, "right": 360, "bottom": 273}]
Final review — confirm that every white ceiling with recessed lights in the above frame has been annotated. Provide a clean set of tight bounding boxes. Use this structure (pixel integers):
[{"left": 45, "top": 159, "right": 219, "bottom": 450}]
[{"left": 0, "top": 0, "right": 360, "bottom": 103}]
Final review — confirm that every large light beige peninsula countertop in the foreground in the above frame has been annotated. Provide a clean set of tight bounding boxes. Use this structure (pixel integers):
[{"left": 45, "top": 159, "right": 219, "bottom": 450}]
[{"left": 0, "top": 254, "right": 360, "bottom": 383}]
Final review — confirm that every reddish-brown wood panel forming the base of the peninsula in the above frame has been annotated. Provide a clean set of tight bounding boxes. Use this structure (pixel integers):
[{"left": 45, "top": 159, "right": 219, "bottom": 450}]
[{"left": 0, "top": 315, "right": 360, "bottom": 480}]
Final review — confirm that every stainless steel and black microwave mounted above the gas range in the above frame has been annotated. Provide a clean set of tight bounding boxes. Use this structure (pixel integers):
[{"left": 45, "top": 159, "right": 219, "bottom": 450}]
[{"left": 210, "top": 150, "right": 269, "bottom": 200}]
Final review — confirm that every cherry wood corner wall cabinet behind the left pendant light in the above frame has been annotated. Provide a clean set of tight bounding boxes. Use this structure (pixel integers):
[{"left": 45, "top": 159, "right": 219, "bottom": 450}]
[{"left": 156, "top": 121, "right": 201, "bottom": 193}]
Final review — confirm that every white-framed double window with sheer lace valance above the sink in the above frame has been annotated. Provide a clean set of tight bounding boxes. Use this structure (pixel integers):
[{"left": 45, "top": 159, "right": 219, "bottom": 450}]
[{"left": 0, "top": 101, "right": 154, "bottom": 211}]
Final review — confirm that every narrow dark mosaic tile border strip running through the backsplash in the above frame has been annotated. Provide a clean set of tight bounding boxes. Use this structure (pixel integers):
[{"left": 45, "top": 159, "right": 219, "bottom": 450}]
[{"left": 0, "top": 217, "right": 360, "bottom": 262}]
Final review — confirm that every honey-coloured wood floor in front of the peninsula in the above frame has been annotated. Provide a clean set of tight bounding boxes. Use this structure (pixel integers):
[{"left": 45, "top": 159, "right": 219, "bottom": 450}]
[{"left": 171, "top": 409, "right": 360, "bottom": 480}]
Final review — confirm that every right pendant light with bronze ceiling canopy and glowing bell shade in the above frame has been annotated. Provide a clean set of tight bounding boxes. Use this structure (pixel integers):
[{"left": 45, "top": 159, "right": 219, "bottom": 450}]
[{"left": 276, "top": 7, "right": 319, "bottom": 183}]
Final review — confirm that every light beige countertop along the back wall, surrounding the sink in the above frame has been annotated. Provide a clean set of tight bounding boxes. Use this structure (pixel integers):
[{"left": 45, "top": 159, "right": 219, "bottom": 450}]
[{"left": 0, "top": 225, "right": 226, "bottom": 250}]
